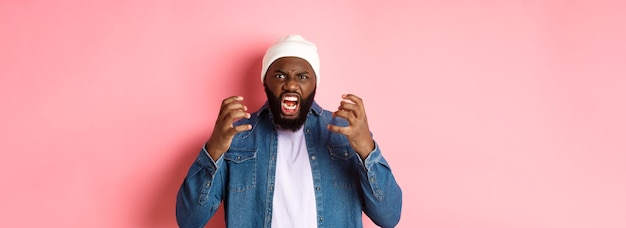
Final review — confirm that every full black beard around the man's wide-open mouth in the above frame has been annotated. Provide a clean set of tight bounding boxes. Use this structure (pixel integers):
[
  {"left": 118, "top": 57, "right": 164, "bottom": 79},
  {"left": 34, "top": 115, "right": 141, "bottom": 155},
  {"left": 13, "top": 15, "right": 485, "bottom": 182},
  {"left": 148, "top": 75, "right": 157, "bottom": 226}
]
[{"left": 265, "top": 86, "right": 317, "bottom": 131}]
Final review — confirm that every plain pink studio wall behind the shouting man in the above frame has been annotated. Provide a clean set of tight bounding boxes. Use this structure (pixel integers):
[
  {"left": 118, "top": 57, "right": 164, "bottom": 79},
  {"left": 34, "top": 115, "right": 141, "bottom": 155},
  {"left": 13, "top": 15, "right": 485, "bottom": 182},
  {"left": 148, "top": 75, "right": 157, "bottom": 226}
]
[{"left": 0, "top": 0, "right": 626, "bottom": 228}]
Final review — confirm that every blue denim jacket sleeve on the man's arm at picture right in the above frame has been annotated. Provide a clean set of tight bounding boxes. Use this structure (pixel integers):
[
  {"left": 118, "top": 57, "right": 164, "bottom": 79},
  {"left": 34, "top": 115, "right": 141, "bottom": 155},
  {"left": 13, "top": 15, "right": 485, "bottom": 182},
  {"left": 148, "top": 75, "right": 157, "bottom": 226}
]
[{"left": 357, "top": 142, "right": 402, "bottom": 227}]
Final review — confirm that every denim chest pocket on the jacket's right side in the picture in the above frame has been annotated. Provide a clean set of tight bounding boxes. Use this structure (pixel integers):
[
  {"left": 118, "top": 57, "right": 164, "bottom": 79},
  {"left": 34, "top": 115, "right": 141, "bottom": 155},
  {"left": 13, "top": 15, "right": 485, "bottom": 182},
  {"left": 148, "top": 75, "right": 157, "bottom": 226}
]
[{"left": 328, "top": 145, "right": 359, "bottom": 188}]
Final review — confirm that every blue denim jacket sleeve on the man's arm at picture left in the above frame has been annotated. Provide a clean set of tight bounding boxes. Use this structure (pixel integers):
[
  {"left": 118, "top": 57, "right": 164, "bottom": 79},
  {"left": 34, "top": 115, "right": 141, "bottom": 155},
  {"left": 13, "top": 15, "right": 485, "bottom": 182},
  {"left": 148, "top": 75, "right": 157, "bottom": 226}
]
[{"left": 176, "top": 146, "right": 224, "bottom": 228}]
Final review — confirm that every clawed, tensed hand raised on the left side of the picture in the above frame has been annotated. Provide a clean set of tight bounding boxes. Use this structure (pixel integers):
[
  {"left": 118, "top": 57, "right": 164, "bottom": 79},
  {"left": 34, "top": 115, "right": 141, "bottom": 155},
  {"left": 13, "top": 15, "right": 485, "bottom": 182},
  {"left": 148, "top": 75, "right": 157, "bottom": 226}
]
[{"left": 206, "top": 96, "right": 252, "bottom": 160}]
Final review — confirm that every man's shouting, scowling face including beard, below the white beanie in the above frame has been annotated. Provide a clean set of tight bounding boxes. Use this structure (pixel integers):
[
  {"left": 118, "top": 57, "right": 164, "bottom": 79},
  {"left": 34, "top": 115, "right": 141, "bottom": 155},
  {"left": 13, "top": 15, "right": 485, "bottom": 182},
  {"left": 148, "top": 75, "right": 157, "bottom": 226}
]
[{"left": 264, "top": 57, "right": 316, "bottom": 131}]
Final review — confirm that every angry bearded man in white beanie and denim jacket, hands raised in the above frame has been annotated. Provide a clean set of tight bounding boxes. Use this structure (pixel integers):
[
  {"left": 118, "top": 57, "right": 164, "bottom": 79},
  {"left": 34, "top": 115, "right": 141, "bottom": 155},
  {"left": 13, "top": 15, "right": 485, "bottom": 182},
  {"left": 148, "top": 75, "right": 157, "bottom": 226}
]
[{"left": 176, "top": 35, "right": 402, "bottom": 227}]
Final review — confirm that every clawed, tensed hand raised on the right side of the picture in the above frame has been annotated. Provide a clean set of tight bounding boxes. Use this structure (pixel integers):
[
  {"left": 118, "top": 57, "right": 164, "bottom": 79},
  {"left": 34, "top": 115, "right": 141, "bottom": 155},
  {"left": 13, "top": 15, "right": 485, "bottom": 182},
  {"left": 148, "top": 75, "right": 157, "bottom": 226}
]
[{"left": 328, "top": 94, "right": 374, "bottom": 160}]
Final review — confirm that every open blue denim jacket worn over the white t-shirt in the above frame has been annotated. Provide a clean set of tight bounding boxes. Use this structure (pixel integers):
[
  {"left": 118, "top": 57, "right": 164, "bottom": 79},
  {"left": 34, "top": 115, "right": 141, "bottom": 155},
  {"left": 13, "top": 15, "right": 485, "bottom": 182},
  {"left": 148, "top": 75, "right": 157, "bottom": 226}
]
[{"left": 176, "top": 102, "right": 402, "bottom": 228}]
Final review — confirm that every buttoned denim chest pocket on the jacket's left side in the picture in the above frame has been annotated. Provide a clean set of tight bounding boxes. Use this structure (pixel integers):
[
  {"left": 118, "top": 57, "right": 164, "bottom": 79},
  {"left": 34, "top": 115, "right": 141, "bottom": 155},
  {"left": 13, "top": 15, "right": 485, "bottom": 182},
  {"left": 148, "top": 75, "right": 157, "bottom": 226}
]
[{"left": 224, "top": 148, "right": 257, "bottom": 192}]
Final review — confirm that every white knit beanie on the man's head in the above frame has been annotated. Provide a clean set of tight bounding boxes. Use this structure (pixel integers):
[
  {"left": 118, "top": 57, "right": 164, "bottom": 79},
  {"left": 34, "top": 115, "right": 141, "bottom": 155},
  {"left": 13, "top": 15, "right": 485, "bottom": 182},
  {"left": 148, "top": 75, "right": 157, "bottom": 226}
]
[{"left": 261, "top": 35, "right": 320, "bottom": 84}]
